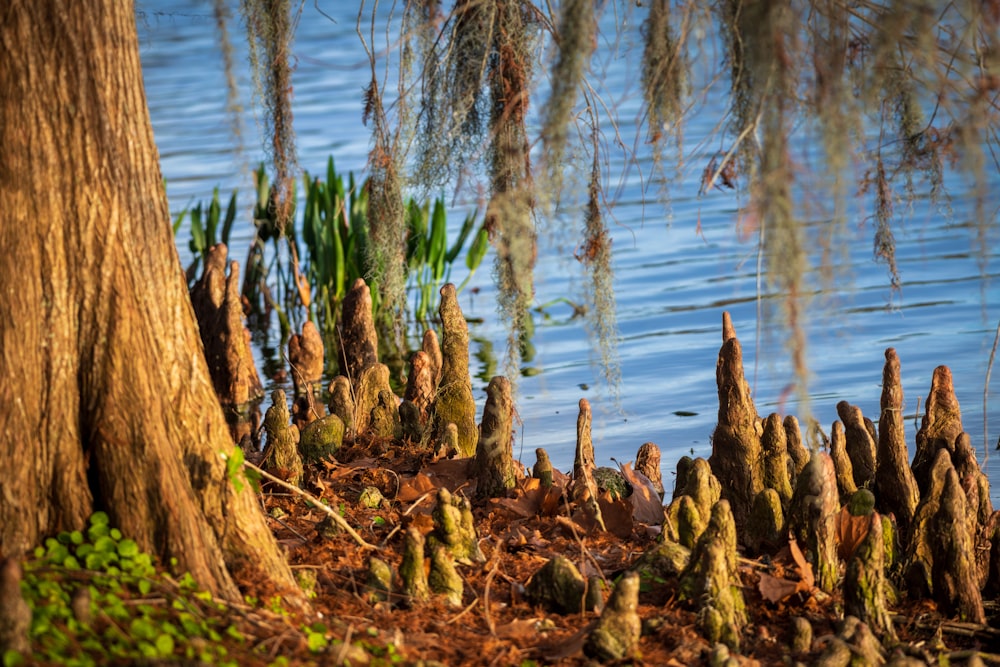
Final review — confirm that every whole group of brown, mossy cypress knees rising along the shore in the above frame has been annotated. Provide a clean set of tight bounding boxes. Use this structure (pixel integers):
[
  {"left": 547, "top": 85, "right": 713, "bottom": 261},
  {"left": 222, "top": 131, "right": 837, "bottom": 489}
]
[{"left": 192, "top": 246, "right": 1000, "bottom": 664}]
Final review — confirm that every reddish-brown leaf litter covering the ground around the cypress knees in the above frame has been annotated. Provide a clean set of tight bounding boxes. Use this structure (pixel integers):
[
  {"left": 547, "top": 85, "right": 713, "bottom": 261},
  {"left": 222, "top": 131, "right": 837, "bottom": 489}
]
[{"left": 219, "top": 438, "right": 1000, "bottom": 666}]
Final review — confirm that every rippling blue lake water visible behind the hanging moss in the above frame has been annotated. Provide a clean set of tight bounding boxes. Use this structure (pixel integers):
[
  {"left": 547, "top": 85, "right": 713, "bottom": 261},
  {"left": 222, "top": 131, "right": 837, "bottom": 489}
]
[{"left": 137, "top": 1, "right": 1000, "bottom": 496}]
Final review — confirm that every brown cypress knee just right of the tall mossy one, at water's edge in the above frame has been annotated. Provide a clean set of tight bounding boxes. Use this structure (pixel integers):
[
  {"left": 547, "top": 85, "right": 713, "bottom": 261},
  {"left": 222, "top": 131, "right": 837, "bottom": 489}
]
[{"left": 476, "top": 375, "right": 519, "bottom": 498}]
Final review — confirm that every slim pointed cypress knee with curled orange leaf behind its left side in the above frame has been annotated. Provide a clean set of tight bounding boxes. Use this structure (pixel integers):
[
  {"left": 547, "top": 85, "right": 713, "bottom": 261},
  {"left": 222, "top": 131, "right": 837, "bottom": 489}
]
[{"left": 844, "top": 512, "right": 896, "bottom": 638}]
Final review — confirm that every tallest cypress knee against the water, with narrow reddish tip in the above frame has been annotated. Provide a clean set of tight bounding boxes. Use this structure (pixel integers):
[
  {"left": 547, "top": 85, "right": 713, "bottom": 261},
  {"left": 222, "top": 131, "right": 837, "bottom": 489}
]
[{"left": 708, "top": 313, "right": 764, "bottom": 530}]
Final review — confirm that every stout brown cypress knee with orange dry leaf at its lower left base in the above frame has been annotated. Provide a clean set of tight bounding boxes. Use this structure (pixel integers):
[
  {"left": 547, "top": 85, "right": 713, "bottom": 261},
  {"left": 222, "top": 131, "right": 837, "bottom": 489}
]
[{"left": 788, "top": 452, "right": 840, "bottom": 593}]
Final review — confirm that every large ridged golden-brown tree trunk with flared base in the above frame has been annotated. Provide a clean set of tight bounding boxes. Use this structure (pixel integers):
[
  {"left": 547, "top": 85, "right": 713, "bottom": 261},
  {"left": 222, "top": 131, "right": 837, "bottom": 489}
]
[{"left": 0, "top": 0, "right": 294, "bottom": 599}]
